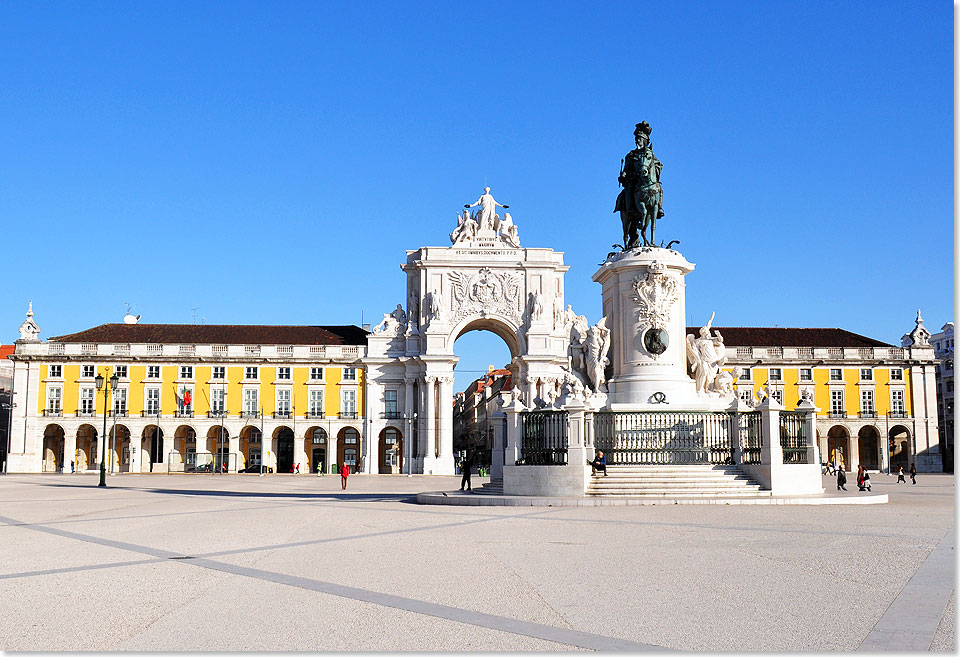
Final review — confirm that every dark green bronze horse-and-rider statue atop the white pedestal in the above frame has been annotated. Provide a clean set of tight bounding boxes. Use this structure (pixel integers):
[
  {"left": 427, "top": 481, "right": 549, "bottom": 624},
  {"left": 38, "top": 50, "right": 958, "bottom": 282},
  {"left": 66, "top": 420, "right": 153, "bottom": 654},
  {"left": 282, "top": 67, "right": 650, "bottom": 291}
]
[{"left": 613, "top": 121, "right": 663, "bottom": 250}]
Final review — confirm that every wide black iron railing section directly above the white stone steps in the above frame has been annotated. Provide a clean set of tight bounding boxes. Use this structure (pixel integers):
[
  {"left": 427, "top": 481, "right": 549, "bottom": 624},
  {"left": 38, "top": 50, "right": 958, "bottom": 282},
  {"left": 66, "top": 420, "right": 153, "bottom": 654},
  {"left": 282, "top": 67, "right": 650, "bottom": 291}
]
[{"left": 593, "top": 411, "right": 736, "bottom": 465}]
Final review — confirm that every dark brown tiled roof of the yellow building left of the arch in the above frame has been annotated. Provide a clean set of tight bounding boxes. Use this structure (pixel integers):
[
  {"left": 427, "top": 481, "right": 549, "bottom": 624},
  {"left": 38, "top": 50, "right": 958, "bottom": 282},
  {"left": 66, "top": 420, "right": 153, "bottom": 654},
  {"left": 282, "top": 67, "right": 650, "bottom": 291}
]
[{"left": 50, "top": 324, "right": 367, "bottom": 345}]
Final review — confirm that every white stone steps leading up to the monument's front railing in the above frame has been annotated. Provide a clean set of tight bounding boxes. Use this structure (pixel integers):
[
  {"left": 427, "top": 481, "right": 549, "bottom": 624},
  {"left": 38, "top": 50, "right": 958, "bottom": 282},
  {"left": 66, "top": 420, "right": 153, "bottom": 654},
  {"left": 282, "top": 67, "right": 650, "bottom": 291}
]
[{"left": 586, "top": 465, "right": 771, "bottom": 499}]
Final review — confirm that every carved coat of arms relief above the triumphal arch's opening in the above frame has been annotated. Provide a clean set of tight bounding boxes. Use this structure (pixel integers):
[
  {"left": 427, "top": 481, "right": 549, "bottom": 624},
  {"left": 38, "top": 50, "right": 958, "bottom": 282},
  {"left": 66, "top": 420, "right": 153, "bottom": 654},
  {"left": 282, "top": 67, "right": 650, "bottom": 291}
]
[{"left": 450, "top": 267, "right": 523, "bottom": 324}]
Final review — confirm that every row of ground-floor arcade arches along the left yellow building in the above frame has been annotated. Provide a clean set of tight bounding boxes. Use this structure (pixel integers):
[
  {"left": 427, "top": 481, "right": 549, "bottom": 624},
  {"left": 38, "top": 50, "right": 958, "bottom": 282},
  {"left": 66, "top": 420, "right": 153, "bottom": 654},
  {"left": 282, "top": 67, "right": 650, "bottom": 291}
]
[{"left": 43, "top": 424, "right": 403, "bottom": 473}]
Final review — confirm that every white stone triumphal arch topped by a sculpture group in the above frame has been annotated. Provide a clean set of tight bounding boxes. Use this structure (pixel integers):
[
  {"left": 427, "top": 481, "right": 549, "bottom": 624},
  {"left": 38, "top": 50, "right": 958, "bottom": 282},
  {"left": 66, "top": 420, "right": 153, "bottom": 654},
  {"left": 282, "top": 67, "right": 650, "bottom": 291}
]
[{"left": 367, "top": 187, "right": 572, "bottom": 474}]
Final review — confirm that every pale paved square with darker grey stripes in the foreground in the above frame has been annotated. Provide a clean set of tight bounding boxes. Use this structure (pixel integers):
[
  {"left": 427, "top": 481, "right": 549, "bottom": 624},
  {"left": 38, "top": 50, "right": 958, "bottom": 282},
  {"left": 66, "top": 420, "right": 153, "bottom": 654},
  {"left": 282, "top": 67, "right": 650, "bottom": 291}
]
[{"left": 0, "top": 475, "right": 955, "bottom": 651}]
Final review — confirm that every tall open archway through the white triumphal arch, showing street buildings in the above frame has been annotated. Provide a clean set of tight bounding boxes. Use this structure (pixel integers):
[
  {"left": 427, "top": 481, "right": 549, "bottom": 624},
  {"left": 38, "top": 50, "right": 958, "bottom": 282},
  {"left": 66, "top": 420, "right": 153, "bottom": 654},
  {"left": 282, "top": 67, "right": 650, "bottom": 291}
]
[{"left": 452, "top": 319, "right": 521, "bottom": 473}]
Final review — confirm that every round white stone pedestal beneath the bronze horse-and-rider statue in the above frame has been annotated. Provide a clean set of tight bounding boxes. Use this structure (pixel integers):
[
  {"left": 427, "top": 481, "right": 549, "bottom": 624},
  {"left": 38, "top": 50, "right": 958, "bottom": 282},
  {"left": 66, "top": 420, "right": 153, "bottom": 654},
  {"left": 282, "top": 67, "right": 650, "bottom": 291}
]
[{"left": 593, "top": 247, "right": 712, "bottom": 411}]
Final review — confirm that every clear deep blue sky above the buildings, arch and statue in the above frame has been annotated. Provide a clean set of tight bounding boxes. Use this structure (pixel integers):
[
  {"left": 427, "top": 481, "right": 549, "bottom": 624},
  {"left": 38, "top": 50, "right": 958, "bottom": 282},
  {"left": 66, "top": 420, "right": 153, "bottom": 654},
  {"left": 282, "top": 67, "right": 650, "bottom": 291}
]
[{"left": 0, "top": 0, "right": 954, "bottom": 388}]
